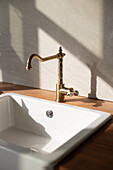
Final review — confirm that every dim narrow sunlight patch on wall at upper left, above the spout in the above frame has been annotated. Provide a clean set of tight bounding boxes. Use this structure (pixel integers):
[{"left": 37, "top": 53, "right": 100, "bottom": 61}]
[{"left": 9, "top": 4, "right": 24, "bottom": 62}]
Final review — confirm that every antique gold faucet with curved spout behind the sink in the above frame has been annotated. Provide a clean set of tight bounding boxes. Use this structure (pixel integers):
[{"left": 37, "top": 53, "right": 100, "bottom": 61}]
[{"left": 26, "top": 47, "right": 79, "bottom": 102}]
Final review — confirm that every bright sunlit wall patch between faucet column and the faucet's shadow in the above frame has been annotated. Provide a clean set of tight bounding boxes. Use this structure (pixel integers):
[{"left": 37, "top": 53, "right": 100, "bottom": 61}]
[{"left": 63, "top": 48, "right": 91, "bottom": 96}]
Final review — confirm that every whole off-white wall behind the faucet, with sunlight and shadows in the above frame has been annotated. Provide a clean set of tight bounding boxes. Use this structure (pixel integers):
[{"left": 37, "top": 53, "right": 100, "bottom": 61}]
[{"left": 0, "top": 0, "right": 113, "bottom": 101}]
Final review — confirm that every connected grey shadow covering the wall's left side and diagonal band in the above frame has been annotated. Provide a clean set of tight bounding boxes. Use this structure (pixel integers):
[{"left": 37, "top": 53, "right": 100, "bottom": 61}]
[{"left": 0, "top": 0, "right": 113, "bottom": 98}]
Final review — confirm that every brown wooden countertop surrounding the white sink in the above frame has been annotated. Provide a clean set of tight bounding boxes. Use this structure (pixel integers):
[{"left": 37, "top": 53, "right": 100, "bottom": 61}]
[{"left": 0, "top": 82, "right": 113, "bottom": 170}]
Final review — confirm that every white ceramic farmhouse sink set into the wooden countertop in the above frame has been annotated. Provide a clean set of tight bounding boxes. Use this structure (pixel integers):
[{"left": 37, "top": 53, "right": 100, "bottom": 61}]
[{"left": 0, "top": 93, "right": 111, "bottom": 170}]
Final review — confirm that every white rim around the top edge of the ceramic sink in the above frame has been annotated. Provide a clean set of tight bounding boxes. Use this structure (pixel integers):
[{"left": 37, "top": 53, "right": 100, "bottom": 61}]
[{"left": 0, "top": 93, "right": 112, "bottom": 165}]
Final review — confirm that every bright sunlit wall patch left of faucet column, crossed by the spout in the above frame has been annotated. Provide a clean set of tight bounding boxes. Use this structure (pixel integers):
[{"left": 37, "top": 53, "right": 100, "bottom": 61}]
[{"left": 37, "top": 28, "right": 60, "bottom": 90}]
